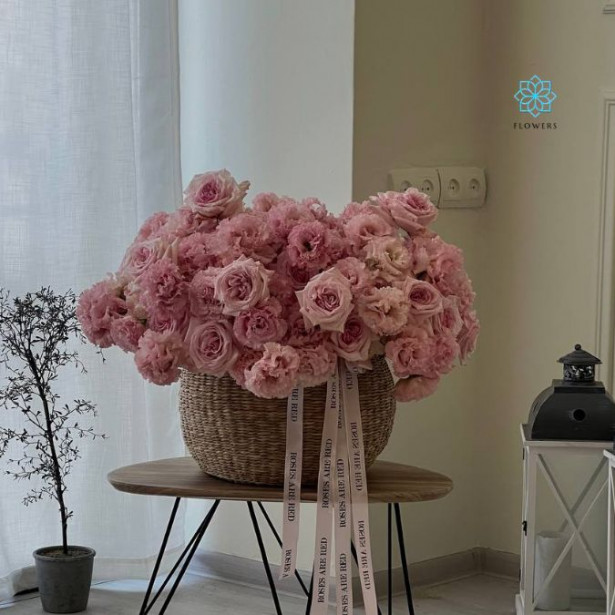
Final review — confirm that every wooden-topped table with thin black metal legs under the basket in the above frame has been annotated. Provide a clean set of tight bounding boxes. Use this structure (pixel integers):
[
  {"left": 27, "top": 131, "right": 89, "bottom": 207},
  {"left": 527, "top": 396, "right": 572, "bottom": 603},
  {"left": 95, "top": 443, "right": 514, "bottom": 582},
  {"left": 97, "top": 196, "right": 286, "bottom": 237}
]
[{"left": 108, "top": 457, "right": 453, "bottom": 615}]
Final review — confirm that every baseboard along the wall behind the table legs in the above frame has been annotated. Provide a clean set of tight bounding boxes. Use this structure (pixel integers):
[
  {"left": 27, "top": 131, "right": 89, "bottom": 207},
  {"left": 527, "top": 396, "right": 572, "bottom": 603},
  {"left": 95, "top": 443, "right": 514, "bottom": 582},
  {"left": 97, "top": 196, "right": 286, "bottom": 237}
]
[{"left": 189, "top": 547, "right": 519, "bottom": 598}]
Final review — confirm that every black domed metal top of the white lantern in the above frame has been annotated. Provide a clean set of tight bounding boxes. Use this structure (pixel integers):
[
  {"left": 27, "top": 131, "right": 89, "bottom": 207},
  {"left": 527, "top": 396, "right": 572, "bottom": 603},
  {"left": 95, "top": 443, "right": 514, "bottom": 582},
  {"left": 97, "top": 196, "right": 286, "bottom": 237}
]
[{"left": 527, "top": 344, "right": 615, "bottom": 441}]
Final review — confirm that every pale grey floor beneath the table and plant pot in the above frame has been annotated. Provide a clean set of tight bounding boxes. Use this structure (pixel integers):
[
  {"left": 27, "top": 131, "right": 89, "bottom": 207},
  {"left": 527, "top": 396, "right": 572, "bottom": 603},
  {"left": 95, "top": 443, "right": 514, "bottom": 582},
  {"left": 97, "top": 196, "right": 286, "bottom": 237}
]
[{"left": 0, "top": 575, "right": 517, "bottom": 615}]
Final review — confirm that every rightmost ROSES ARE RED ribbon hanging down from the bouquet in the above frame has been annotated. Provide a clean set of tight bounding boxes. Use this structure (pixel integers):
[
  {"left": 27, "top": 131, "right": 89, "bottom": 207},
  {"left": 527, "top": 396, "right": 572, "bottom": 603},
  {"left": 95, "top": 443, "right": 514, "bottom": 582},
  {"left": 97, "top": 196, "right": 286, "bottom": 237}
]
[{"left": 340, "top": 363, "right": 378, "bottom": 615}]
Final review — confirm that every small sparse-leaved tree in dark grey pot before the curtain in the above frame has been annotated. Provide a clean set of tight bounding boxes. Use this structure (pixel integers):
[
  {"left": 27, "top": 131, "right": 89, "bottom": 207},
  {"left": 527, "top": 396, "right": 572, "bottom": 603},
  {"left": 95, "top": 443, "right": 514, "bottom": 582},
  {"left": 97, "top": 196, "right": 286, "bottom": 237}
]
[{"left": 0, "top": 288, "right": 104, "bottom": 613}]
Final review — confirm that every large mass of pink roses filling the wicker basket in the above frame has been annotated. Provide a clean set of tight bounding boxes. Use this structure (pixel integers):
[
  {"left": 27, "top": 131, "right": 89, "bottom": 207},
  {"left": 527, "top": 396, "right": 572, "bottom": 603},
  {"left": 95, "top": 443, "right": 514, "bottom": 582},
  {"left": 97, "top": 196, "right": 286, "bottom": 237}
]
[{"left": 77, "top": 170, "right": 479, "bottom": 401}]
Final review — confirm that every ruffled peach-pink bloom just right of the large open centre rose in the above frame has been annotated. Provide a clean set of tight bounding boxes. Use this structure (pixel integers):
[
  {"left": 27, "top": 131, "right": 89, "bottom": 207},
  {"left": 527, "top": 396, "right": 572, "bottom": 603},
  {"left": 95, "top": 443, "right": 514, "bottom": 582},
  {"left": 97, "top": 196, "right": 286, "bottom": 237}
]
[{"left": 358, "top": 286, "right": 408, "bottom": 335}]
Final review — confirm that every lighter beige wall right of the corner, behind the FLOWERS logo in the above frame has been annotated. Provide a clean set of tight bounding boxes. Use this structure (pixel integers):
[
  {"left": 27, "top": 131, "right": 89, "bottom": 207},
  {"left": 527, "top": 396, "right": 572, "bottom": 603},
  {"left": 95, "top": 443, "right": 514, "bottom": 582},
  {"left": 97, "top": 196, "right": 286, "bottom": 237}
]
[{"left": 477, "top": 0, "right": 615, "bottom": 551}]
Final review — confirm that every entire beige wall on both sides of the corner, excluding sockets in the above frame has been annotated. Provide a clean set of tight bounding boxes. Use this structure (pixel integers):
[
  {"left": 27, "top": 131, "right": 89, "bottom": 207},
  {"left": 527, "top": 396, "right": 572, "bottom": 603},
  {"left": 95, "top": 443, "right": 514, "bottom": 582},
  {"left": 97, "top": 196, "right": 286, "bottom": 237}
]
[{"left": 353, "top": 0, "right": 615, "bottom": 561}]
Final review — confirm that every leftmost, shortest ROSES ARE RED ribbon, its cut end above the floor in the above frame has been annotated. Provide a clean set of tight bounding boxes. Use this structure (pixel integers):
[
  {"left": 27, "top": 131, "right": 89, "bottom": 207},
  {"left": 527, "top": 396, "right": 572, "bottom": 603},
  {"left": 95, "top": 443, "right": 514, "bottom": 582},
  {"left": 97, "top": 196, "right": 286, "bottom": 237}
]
[{"left": 280, "top": 387, "right": 303, "bottom": 579}]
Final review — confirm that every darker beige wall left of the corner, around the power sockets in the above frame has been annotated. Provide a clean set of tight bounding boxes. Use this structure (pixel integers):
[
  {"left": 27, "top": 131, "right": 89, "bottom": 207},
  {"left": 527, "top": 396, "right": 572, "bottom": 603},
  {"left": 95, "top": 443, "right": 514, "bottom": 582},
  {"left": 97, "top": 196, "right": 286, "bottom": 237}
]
[{"left": 353, "top": 0, "right": 485, "bottom": 563}]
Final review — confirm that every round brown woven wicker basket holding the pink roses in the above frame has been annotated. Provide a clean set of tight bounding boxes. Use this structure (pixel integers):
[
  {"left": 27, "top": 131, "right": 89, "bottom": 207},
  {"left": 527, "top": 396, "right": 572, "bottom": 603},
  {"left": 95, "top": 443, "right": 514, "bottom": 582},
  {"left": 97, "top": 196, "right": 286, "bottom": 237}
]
[{"left": 179, "top": 357, "right": 395, "bottom": 485}]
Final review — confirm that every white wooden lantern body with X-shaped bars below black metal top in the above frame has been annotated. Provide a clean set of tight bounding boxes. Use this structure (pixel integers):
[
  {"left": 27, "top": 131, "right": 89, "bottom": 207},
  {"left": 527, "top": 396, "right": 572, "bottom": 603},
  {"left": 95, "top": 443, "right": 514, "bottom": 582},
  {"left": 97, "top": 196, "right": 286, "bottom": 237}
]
[{"left": 516, "top": 425, "right": 615, "bottom": 615}]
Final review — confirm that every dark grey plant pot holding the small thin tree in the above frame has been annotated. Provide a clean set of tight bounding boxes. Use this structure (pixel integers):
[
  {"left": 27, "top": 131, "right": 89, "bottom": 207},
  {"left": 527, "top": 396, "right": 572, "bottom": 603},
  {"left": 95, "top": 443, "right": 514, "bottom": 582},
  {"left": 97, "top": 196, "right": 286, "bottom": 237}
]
[{"left": 33, "top": 546, "right": 96, "bottom": 613}]
